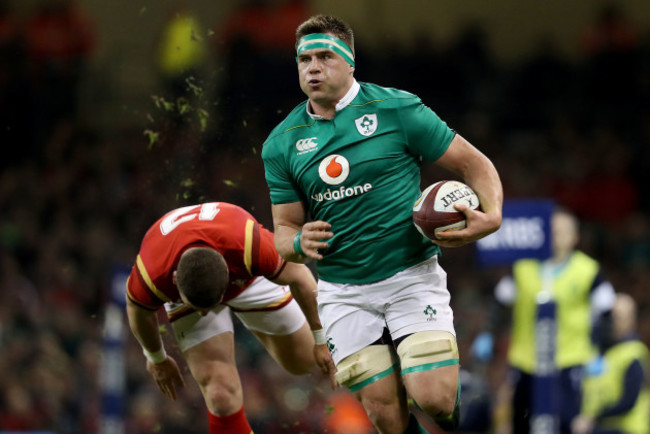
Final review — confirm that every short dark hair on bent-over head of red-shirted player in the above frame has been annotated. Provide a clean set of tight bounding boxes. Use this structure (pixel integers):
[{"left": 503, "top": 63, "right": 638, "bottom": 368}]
[{"left": 176, "top": 247, "right": 228, "bottom": 309}]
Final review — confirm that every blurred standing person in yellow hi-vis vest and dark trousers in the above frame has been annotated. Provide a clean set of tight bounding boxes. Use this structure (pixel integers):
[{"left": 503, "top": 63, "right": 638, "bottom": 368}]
[{"left": 472, "top": 209, "right": 614, "bottom": 434}]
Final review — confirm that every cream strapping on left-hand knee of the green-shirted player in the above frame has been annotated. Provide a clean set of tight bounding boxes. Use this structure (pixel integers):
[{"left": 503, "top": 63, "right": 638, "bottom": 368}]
[{"left": 336, "top": 345, "right": 398, "bottom": 392}]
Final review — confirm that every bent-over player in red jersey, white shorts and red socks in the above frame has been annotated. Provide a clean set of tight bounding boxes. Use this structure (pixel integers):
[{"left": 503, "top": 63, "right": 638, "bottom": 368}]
[{"left": 127, "top": 202, "right": 334, "bottom": 434}]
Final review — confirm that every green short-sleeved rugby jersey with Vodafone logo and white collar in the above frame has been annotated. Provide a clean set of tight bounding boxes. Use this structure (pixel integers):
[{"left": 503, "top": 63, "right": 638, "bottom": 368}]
[{"left": 262, "top": 82, "right": 455, "bottom": 284}]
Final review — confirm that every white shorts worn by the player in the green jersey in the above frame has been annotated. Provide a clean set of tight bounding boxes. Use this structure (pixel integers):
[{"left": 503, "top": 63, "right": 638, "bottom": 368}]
[{"left": 318, "top": 256, "right": 456, "bottom": 364}]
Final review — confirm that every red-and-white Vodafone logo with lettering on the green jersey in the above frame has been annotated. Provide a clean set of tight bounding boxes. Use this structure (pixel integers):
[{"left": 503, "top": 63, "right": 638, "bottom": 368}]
[{"left": 311, "top": 154, "right": 372, "bottom": 202}]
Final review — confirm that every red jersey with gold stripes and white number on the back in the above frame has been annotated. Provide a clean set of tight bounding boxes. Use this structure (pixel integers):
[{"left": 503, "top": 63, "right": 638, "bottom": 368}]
[{"left": 127, "top": 202, "right": 285, "bottom": 310}]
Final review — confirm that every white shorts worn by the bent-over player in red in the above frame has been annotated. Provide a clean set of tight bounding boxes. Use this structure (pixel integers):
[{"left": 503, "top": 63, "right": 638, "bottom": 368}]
[{"left": 165, "top": 277, "right": 306, "bottom": 351}]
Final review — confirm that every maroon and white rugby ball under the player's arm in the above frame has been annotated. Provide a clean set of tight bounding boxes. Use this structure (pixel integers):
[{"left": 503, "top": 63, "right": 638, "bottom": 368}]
[{"left": 413, "top": 181, "right": 480, "bottom": 240}]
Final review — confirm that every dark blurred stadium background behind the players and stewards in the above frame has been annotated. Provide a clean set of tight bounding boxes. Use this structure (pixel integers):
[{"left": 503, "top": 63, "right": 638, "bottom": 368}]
[{"left": 0, "top": 0, "right": 650, "bottom": 433}]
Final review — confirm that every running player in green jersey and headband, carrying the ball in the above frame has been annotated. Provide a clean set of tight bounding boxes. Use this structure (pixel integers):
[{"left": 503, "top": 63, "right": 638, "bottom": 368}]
[{"left": 262, "top": 15, "right": 503, "bottom": 433}]
